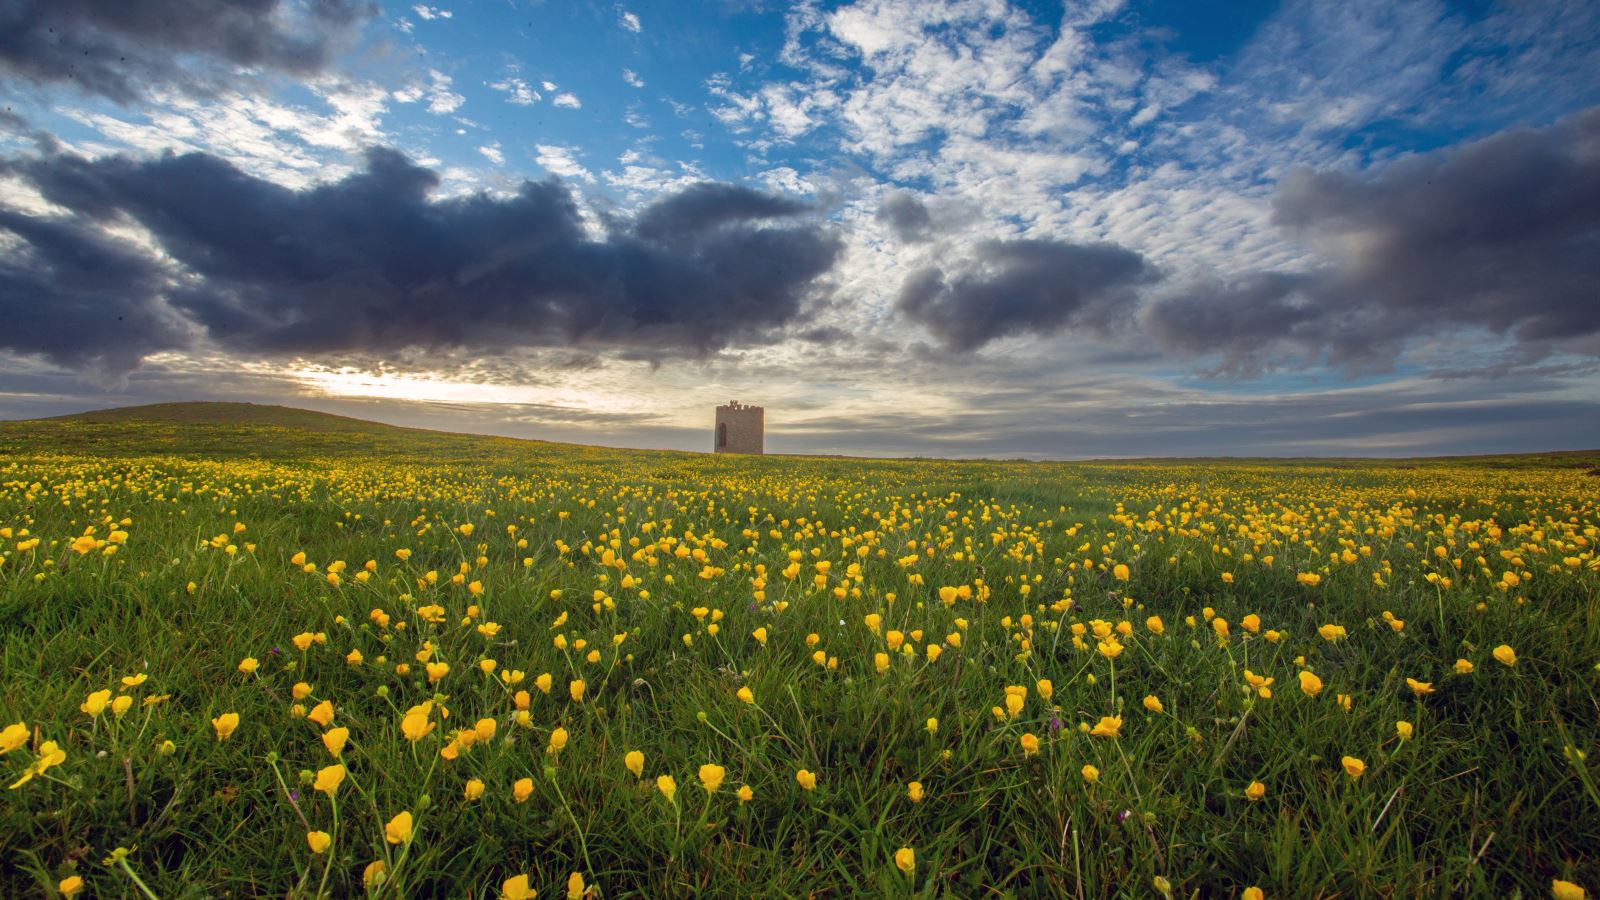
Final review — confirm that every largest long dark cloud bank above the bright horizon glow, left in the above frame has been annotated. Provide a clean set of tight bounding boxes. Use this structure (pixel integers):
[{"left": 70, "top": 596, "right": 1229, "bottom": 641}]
[{"left": 0, "top": 149, "right": 840, "bottom": 368}]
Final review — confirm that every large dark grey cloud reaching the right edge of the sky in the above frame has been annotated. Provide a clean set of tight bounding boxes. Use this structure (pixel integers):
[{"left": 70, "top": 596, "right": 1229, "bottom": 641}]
[{"left": 1147, "top": 109, "right": 1600, "bottom": 370}]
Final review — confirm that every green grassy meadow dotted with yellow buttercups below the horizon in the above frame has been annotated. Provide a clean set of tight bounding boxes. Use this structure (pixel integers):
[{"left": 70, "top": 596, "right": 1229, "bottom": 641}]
[{"left": 0, "top": 405, "right": 1600, "bottom": 897}]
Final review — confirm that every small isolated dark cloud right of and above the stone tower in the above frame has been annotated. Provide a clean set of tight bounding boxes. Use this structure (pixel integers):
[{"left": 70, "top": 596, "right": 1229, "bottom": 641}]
[{"left": 894, "top": 240, "right": 1158, "bottom": 351}]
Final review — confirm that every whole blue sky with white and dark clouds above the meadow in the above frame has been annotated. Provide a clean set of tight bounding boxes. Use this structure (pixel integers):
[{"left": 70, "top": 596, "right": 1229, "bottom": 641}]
[{"left": 0, "top": 0, "right": 1600, "bottom": 458}]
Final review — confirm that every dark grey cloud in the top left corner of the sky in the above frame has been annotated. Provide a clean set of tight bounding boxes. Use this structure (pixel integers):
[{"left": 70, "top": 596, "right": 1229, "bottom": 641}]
[{"left": 0, "top": 0, "right": 378, "bottom": 102}]
